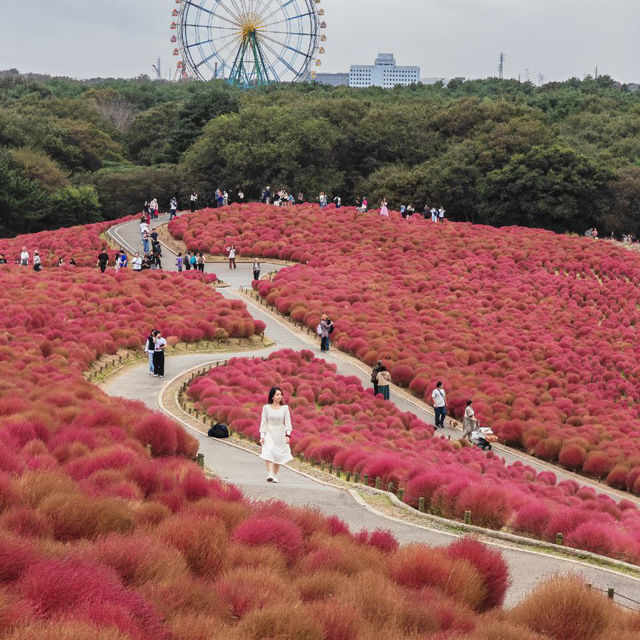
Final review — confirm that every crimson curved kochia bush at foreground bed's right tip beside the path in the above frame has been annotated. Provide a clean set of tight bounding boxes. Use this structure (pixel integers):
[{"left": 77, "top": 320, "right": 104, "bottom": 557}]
[{"left": 446, "top": 537, "right": 511, "bottom": 611}]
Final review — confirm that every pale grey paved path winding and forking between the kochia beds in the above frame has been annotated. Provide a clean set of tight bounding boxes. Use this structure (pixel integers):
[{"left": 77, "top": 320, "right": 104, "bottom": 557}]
[{"left": 103, "top": 216, "right": 640, "bottom": 606}]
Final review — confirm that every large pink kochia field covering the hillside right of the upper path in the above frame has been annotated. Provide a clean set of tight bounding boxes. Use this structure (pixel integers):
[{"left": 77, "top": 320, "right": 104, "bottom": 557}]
[{"left": 170, "top": 204, "right": 640, "bottom": 495}]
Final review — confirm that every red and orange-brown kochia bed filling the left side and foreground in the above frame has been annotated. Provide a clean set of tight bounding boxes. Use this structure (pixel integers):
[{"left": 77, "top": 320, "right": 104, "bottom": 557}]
[{"left": 0, "top": 224, "right": 637, "bottom": 640}]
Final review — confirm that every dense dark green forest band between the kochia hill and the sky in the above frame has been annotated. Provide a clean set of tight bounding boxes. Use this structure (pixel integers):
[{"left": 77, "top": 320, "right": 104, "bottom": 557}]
[{"left": 0, "top": 73, "right": 640, "bottom": 236}]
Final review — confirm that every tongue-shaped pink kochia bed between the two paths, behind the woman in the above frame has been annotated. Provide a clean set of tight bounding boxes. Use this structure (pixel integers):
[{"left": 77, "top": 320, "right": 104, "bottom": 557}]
[{"left": 188, "top": 350, "right": 640, "bottom": 563}]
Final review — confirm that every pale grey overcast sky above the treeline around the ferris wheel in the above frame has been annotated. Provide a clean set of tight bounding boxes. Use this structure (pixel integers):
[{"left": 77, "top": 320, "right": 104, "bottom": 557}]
[{"left": 0, "top": 0, "right": 640, "bottom": 82}]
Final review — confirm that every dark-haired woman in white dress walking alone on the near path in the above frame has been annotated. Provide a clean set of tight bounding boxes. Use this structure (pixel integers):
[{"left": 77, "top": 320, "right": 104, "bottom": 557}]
[{"left": 260, "top": 387, "right": 293, "bottom": 482}]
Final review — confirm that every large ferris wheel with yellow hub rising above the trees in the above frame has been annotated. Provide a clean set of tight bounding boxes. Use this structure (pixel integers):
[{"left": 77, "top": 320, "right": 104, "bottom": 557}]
[{"left": 171, "top": 0, "right": 327, "bottom": 87}]
